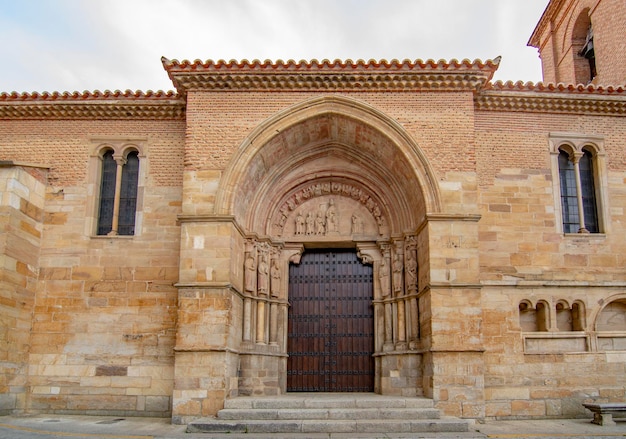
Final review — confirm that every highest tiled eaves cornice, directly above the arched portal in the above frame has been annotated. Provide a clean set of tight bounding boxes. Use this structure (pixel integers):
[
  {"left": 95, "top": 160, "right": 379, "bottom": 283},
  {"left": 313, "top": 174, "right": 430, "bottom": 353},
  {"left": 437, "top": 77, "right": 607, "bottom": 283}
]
[{"left": 161, "top": 58, "right": 500, "bottom": 95}]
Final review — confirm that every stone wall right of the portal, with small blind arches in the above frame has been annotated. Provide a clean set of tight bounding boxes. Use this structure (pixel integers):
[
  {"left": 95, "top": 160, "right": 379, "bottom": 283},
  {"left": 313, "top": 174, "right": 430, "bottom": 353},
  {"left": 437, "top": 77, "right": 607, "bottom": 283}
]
[{"left": 476, "top": 107, "right": 626, "bottom": 418}]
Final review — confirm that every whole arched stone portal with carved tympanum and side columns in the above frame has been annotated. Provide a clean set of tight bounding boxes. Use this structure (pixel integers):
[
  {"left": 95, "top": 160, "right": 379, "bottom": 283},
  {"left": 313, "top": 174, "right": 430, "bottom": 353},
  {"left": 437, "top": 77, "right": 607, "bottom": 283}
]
[{"left": 215, "top": 97, "right": 440, "bottom": 395}]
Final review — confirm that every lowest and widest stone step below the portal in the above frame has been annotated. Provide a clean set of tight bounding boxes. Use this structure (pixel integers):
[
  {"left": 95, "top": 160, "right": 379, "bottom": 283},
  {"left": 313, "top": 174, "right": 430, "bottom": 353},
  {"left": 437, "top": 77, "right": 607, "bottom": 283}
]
[{"left": 187, "top": 418, "right": 471, "bottom": 433}]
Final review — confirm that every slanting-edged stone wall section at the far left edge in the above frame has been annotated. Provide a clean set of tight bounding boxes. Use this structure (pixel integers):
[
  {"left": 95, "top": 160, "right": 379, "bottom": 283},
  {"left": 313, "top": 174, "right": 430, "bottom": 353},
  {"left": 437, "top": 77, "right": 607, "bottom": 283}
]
[{"left": 0, "top": 162, "right": 47, "bottom": 414}]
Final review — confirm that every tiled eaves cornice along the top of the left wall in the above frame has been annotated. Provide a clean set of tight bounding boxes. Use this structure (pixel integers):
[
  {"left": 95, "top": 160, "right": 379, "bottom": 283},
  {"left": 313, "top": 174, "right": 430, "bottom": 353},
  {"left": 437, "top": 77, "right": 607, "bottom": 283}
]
[{"left": 0, "top": 90, "right": 185, "bottom": 120}]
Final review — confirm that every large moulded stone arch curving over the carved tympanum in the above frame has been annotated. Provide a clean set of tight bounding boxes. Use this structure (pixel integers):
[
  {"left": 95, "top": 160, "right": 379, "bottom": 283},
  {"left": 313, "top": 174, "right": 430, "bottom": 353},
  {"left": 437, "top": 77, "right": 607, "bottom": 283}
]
[{"left": 215, "top": 96, "right": 442, "bottom": 235}]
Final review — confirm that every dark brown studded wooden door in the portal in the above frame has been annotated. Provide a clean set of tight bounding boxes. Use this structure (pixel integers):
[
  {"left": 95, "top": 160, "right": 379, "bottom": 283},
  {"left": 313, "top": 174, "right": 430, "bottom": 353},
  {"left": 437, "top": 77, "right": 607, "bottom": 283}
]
[{"left": 287, "top": 250, "right": 374, "bottom": 392}]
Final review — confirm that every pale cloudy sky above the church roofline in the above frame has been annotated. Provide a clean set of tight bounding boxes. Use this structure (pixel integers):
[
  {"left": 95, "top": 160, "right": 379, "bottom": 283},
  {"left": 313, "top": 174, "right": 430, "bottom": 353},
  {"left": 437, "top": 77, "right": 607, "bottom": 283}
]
[{"left": 0, "top": 0, "right": 548, "bottom": 92}]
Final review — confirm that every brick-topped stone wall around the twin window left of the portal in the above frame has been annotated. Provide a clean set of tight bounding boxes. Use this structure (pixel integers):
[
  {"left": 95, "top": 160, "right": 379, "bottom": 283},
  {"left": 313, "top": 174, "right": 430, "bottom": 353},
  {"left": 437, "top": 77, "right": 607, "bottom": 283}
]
[{"left": 0, "top": 119, "right": 184, "bottom": 416}]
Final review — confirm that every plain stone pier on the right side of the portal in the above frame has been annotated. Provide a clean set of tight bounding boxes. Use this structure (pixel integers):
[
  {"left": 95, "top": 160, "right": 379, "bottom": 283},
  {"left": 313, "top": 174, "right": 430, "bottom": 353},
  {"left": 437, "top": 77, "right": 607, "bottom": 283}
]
[{"left": 419, "top": 215, "right": 484, "bottom": 418}]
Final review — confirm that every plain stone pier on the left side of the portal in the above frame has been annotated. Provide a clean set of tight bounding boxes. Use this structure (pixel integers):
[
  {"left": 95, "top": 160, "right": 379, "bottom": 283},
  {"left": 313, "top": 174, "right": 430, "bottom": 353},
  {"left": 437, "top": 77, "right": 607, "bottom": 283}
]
[{"left": 172, "top": 216, "right": 244, "bottom": 423}]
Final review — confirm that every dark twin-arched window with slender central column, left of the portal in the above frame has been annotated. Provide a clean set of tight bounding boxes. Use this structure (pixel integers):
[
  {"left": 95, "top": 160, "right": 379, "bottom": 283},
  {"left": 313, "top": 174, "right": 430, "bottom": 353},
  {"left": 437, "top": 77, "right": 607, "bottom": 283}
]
[{"left": 98, "top": 151, "right": 139, "bottom": 236}]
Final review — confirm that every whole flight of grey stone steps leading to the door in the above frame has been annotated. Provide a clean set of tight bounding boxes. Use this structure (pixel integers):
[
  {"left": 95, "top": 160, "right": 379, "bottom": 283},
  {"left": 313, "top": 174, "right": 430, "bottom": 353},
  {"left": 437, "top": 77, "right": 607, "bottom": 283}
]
[{"left": 187, "top": 393, "right": 472, "bottom": 433}]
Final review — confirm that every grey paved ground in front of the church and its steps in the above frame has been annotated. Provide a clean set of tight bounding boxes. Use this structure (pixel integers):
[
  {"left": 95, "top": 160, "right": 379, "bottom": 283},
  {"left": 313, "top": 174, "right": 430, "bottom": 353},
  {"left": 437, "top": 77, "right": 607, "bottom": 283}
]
[{"left": 0, "top": 415, "right": 626, "bottom": 439}]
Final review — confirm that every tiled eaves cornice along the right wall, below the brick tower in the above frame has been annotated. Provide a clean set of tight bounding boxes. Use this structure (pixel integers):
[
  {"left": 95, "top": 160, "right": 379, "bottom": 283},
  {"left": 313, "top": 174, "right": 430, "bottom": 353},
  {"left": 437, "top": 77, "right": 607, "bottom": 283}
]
[{"left": 474, "top": 81, "right": 626, "bottom": 116}]
